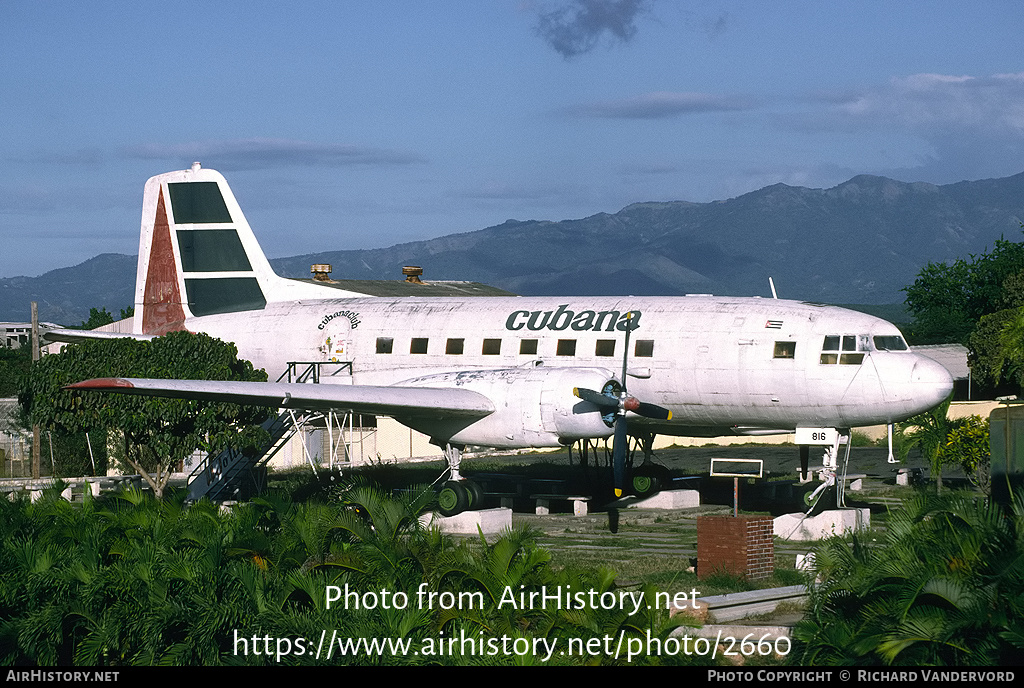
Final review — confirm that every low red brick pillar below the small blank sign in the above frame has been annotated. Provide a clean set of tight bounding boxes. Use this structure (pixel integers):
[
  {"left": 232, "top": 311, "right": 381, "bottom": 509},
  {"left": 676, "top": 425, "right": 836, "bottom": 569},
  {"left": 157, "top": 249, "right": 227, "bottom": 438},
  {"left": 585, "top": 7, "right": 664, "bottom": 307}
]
[{"left": 697, "top": 516, "right": 775, "bottom": 578}]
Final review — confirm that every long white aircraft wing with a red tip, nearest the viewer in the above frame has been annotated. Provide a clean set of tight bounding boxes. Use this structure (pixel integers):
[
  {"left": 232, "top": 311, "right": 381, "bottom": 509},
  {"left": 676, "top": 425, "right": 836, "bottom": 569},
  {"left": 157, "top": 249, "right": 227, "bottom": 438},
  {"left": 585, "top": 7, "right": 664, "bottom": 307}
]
[{"left": 68, "top": 378, "right": 495, "bottom": 419}]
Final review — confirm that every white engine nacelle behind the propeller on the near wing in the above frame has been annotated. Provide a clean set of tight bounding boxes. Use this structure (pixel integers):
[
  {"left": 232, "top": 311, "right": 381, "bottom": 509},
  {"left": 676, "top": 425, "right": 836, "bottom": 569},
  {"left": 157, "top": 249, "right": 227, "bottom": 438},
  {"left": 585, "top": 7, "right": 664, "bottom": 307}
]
[{"left": 397, "top": 367, "right": 613, "bottom": 448}]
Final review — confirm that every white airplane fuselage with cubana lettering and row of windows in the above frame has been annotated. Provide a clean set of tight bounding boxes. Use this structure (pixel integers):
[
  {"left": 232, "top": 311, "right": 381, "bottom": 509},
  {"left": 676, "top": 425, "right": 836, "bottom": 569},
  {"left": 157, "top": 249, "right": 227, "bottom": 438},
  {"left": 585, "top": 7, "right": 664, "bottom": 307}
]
[{"left": 188, "top": 296, "right": 952, "bottom": 436}]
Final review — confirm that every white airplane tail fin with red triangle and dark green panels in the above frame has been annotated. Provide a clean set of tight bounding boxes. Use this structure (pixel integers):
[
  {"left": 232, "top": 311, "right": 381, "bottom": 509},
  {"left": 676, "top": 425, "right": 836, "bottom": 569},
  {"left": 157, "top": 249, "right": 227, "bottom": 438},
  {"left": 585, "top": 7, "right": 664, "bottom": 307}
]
[{"left": 135, "top": 163, "right": 344, "bottom": 335}]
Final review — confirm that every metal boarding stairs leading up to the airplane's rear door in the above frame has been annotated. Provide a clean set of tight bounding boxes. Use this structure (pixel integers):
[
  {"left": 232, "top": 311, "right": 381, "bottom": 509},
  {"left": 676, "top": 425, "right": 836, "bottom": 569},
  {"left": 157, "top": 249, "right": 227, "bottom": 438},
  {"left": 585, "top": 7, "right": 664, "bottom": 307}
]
[{"left": 187, "top": 361, "right": 352, "bottom": 502}]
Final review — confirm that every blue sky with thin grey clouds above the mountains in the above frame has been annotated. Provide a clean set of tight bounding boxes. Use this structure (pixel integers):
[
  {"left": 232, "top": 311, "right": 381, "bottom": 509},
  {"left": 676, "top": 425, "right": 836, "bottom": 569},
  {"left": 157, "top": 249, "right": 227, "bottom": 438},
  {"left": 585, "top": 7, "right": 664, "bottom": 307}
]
[{"left": 0, "top": 0, "right": 1024, "bottom": 276}]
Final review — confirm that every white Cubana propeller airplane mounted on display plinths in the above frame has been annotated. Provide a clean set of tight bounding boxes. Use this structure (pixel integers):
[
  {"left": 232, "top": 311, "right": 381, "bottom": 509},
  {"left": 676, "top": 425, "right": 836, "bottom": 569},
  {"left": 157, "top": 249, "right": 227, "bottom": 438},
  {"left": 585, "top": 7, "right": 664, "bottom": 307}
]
[{"left": 54, "top": 163, "right": 952, "bottom": 514}]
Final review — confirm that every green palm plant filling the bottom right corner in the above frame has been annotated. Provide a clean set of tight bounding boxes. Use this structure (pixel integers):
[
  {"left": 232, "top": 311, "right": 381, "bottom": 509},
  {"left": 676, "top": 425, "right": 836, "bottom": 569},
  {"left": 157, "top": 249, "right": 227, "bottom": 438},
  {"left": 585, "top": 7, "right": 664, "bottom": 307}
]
[{"left": 791, "top": 495, "right": 1024, "bottom": 665}]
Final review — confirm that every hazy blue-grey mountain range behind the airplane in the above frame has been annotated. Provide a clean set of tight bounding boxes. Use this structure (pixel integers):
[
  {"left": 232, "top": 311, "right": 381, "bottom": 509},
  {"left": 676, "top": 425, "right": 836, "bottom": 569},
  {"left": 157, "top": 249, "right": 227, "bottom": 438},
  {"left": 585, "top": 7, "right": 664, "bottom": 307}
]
[{"left": 0, "top": 173, "right": 1024, "bottom": 325}]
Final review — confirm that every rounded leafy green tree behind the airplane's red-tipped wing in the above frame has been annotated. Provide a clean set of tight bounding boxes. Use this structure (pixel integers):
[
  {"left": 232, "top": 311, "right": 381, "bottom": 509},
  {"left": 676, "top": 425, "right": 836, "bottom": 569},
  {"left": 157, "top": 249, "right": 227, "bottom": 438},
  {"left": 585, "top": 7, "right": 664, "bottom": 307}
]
[{"left": 20, "top": 332, "right": 267, "bottom": 498}]
